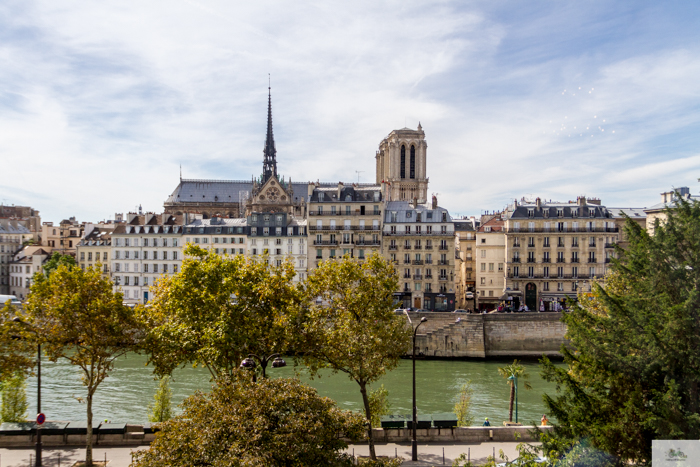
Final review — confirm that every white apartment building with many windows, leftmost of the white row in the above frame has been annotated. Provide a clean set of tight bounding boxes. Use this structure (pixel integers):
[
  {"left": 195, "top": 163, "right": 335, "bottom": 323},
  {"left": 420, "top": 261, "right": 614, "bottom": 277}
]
[{"left": 111, "top": 213, "right": 184, "bottom": 304}]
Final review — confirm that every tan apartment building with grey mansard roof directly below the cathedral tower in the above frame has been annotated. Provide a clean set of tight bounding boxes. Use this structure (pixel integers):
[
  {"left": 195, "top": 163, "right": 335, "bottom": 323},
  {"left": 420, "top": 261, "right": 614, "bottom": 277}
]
[{"left": 382, "top": 196, "right": 455, "bottom": 311}]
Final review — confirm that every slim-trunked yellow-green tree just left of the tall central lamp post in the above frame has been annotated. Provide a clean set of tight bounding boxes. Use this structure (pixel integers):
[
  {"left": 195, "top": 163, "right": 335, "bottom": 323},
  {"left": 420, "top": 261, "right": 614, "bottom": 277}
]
[{"left": 299, "top": 254, "right": 411, "bottom": 459}]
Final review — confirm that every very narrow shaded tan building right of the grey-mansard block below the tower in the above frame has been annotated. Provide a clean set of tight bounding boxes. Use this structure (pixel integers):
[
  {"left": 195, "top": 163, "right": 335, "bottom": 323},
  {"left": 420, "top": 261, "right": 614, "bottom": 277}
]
[{"left": 454, "top": 218, "right": 477, "bottom": 310}]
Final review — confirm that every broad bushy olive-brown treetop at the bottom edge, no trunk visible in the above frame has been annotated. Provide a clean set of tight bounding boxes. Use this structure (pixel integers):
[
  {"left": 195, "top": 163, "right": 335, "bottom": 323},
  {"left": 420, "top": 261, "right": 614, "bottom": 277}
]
[{"left": 131, "top": 371, "right": 363, "bottom": 467}]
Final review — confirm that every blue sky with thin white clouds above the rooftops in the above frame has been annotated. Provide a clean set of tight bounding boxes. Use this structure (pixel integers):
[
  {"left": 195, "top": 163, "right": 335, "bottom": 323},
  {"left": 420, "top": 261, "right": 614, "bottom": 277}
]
[{"left": 0, "top": 0, "right": 700, "bottom": 222}]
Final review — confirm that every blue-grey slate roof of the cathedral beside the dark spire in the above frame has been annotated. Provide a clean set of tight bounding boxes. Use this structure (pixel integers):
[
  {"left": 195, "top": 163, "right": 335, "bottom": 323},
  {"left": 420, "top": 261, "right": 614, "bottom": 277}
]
[{"left": 165, "top": 180, "right": 308, "bottom": 205}]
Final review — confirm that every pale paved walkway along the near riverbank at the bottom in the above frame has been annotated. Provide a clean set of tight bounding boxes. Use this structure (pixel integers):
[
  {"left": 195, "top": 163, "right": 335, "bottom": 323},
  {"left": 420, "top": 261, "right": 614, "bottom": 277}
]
[{"left": 0, "top": 442, "right": 532, "bottom": 467}]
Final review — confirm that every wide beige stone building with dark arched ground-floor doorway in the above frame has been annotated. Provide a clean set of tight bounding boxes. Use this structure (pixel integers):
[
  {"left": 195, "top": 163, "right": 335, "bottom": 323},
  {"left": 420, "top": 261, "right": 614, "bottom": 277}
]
[{"left": 505, "top": 197, "right": 620, "bottom": 311}]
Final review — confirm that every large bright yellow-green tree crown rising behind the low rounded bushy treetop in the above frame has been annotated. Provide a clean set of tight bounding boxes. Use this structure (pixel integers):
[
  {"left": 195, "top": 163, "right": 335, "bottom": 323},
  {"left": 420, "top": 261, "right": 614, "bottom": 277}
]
[{"left": 142, "top": 245, "right": 299, "bottom": 378}]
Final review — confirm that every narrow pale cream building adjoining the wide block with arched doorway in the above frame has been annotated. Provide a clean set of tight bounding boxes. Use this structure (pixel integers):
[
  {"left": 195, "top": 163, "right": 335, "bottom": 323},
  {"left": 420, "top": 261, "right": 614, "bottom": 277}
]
[{"left": 475, "top": 214, "right": 506, "bottom": 310}]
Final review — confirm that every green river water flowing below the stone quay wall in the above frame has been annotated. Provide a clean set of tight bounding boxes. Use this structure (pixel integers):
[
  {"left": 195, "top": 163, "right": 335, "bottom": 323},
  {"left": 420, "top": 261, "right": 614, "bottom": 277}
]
[{"left": 27, "top": 354, "right": 568, "bottom": 425}]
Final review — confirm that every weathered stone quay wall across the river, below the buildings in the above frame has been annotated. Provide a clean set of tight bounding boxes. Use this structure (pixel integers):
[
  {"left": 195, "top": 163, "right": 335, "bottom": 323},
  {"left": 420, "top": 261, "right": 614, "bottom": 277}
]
[{"left": 409, "top": 312, "right": 567, "bottom": 358}]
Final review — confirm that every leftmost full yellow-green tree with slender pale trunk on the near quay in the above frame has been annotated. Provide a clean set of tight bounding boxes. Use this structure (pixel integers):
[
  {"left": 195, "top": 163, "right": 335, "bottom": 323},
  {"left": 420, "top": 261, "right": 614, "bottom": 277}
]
[{"left": 24, "top": 264, "right": 141, "bottom": 466}]
